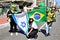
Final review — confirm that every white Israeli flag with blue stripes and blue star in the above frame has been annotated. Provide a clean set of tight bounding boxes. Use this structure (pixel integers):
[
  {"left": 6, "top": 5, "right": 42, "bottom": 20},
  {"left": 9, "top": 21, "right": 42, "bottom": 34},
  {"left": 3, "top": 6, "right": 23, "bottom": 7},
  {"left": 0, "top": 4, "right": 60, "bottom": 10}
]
[{"left": 12, "top": 12, "right": 28, "bottom": 34}]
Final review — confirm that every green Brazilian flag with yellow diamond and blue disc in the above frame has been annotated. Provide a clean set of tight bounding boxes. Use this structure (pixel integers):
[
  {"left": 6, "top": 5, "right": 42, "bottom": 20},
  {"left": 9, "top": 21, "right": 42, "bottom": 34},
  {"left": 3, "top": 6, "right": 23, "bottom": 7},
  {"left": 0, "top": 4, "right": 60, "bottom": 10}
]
[{"left": 28, "top": 7, "right": 46, "bottom": 23}]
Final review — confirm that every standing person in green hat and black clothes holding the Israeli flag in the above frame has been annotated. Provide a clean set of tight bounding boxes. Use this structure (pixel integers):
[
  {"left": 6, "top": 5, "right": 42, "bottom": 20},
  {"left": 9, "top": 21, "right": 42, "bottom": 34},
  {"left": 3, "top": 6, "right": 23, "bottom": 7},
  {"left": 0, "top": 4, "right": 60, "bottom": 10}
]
[{"left": 7, "top": 5, "right": 17, "bottom": 33}]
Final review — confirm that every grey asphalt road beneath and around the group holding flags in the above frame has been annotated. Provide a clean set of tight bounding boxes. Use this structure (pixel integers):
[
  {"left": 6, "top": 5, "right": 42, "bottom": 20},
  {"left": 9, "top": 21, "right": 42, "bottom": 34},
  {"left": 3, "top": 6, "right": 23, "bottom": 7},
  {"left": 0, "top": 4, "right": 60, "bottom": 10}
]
[{"left": 0, "top": 13, "right": 60, "bottom": 40}]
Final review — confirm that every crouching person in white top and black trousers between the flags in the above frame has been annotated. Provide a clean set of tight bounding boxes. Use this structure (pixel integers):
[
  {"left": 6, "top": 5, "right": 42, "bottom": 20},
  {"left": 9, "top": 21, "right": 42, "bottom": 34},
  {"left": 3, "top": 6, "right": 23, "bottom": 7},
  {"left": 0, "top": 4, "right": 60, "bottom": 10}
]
[{"left": 27, "top": 18, "right": 38, "bottom": 39}]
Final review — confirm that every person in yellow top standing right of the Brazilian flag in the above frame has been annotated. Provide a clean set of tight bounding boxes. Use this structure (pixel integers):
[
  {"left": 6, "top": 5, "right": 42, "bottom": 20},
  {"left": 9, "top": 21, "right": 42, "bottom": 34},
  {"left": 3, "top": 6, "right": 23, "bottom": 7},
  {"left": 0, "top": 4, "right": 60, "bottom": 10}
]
[{"left": 47, "top": 8, "right": 56, "bottom": 27}]
